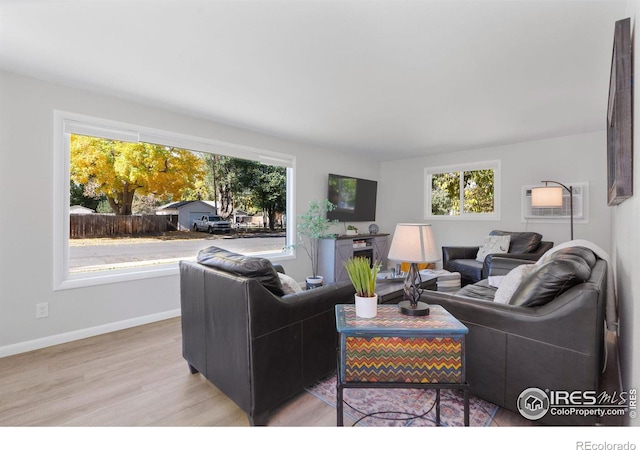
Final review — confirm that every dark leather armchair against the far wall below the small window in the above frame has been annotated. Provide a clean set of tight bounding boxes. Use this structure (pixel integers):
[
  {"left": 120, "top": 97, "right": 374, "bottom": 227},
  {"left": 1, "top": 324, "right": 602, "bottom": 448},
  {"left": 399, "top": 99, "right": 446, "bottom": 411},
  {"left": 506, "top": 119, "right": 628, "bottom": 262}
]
[{"left": 442, "top": 230, "right": 553, "bottom": 286}]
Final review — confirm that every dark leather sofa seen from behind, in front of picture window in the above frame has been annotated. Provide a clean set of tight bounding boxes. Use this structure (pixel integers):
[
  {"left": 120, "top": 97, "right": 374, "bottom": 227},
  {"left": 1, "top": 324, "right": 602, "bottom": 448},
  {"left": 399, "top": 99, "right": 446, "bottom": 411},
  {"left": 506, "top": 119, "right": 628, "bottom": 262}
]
[{"left": 180, "top": 247, "right": 355, "bottom": 425}]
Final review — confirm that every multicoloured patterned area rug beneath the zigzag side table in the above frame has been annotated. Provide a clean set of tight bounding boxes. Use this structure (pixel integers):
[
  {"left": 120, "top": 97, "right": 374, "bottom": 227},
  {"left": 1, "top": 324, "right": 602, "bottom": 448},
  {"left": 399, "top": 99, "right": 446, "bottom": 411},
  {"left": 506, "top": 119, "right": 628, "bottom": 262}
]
[{"left": 306, "top": 375, "right": 498, "bottom": 427}]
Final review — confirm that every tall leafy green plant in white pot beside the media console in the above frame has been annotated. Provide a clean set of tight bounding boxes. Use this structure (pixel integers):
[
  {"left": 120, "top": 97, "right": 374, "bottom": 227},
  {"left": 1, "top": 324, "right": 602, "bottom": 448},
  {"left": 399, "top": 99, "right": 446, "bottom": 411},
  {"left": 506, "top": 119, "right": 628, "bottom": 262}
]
[{"left": 291, "top": 199, "right": 338, "bottom": 289}]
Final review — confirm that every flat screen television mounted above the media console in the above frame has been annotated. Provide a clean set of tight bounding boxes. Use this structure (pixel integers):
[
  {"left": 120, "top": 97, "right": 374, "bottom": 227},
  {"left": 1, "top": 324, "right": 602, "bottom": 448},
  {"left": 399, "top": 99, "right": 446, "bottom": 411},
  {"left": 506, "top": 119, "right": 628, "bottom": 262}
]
[{"left": 327, "top": 173, "right": 378, "bottom": 222}]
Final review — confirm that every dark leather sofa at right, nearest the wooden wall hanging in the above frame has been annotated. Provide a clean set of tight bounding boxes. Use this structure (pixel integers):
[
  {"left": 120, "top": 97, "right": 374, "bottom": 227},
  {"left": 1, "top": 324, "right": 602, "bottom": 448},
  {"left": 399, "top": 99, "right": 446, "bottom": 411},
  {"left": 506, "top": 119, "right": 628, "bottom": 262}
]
[{"left": 421, "top": 247, "right": 607, "bottom": 425}]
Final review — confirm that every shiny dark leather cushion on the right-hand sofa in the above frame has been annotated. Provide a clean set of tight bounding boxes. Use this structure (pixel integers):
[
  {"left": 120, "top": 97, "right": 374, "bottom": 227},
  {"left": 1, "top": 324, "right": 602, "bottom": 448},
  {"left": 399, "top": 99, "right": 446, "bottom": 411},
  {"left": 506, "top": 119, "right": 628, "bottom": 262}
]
[{"left": 509, "top": 253, "right": 591, "bottom": 306}]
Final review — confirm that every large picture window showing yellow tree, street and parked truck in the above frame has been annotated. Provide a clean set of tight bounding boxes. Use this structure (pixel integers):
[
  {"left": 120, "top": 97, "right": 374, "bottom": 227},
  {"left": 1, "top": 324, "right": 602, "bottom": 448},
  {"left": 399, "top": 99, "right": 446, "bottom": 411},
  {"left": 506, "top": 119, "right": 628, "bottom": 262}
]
[{"left": 55, "top": 114, "right": 293, "bottom": 288}]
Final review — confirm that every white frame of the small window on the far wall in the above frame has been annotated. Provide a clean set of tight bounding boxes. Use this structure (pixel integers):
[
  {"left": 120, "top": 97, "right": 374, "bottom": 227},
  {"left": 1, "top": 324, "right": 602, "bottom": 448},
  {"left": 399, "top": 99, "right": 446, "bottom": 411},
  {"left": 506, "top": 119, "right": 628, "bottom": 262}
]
[{"left": 424, "top": 160, "right": 501, "bottom": 221}]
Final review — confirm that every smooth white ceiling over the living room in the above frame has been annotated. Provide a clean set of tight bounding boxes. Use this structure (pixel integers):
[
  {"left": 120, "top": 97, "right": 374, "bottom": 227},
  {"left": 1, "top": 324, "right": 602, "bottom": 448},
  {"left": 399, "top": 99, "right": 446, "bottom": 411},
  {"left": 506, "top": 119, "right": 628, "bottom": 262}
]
[{"left": 0, "top": 0, "right": 625, "bottom": 160}]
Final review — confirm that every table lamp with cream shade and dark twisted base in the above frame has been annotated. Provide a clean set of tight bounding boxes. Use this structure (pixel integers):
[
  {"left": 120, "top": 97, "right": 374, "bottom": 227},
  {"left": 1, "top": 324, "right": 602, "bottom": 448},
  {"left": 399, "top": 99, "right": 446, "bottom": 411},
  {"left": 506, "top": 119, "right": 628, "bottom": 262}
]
[{"left": 388, "top": 223, "right": 440, "bottom": 316}]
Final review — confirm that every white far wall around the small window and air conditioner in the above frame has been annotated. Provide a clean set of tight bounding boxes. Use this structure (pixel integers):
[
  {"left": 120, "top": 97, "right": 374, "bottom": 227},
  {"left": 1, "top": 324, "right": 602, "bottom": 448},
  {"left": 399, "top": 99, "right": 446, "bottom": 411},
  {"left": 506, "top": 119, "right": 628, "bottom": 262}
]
[{"left": 378, "top": 132, "right": 610, "bottom": 260}]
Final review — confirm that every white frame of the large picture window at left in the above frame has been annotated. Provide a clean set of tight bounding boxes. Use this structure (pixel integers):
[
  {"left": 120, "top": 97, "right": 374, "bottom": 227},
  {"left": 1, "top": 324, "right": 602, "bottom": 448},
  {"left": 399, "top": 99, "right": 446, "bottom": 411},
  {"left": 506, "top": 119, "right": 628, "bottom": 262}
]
[{"left": 52, "top": 110, "right": 296, "bottom": 291}]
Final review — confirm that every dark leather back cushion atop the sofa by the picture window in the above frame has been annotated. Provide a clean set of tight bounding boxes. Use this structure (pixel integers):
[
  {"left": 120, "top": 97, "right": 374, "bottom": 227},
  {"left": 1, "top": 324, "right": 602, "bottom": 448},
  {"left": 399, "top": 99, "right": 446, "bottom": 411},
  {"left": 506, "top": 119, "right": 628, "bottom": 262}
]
[{"left": 197, "top": 247, "right": 284, "bottom": 296}]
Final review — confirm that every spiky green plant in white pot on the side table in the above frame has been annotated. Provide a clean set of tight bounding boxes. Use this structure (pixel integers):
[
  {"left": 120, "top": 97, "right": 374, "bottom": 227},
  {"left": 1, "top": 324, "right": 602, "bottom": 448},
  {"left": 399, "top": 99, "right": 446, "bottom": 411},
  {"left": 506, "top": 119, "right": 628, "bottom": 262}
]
[{"left": 344, "top": 256, "right": 380, "bottom": 318}]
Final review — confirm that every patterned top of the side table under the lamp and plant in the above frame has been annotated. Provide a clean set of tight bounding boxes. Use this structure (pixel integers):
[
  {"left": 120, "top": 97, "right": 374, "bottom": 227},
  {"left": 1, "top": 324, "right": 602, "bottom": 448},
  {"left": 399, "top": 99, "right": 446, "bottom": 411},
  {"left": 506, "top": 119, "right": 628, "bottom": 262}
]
[{"left": 335, "top": 305, "right": 469, "bottom": 336}]
